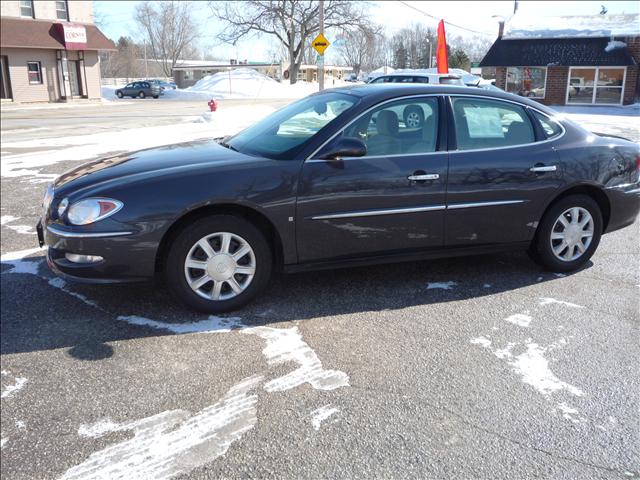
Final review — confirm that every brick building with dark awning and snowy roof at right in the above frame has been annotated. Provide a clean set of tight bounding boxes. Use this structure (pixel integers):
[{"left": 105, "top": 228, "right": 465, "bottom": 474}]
[{"left": 480, "top": 15, "right": 640, "bottom": 105}]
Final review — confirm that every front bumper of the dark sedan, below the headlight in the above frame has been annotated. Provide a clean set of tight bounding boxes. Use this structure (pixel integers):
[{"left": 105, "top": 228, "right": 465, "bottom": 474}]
[{"left": 36, "top": 221, "right": 157, "bottom": 283}]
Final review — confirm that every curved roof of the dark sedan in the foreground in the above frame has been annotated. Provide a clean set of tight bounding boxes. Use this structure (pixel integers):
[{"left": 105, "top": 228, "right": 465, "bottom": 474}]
[{"left": 314, "top": 83, "right": 556, "bottom": 115}]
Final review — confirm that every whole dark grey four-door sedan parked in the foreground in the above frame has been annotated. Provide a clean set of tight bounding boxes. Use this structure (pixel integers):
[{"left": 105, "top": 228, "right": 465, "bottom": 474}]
[{"left": 38, "top": 84, "right": 640, "bottom": 312}]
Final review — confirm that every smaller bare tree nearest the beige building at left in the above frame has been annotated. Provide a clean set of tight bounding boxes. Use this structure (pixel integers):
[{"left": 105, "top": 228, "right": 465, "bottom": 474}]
[{"left": 135, "top": 1, "right": 199, "bottom": 77}]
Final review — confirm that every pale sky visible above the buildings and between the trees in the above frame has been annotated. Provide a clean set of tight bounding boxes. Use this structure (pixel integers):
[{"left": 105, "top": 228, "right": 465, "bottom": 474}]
[{"left": 93, "top": 0, "right": 640, "bottom": 60}]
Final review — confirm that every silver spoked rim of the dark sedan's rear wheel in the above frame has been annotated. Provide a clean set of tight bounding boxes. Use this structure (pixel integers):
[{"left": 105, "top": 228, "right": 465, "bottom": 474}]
[{"left": 550, "top": 207, "right": 594, "bottom": 262}]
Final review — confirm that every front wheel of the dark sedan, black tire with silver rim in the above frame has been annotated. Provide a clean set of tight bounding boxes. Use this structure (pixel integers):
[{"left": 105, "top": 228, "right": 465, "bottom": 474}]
[{"left": 166, "top": 215, "right": 273, "bottom": 313}]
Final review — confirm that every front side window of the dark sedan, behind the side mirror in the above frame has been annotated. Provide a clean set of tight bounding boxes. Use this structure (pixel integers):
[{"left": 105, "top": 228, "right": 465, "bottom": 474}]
[{"left": 343, "top": 97, "right": 438, "bottom": 157}]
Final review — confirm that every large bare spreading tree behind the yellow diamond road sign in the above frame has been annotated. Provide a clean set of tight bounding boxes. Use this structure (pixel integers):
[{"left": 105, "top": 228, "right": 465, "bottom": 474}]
[{"left": 209, "top": 0, "right": 369, "bottom": 83}]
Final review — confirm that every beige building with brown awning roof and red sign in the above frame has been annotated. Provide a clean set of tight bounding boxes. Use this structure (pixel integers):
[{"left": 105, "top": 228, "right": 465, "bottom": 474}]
[{"left": 0, "top": 0, "right": 116, "bottom": 102}]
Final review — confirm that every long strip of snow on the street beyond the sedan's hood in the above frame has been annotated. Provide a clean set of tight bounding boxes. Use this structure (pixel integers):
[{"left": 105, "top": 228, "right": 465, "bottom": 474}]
[{"left": 0, "top": 105, "right": 275, "bottom": 182}]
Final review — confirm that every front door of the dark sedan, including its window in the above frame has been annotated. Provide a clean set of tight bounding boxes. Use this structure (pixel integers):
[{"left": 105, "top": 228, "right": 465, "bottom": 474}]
[{"left": 296, "top": 96, "right": 447, "bottom": 262}]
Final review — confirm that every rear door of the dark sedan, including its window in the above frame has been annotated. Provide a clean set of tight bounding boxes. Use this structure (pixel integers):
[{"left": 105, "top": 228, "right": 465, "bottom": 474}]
[{"left": 445, "top": 97, "right": 562, "bottom": 247}]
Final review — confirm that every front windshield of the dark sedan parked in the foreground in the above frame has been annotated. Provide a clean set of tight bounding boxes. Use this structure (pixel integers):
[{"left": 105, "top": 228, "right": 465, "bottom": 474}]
[{"left": 226, "top": 92, "right": 358, "bottom": 159}]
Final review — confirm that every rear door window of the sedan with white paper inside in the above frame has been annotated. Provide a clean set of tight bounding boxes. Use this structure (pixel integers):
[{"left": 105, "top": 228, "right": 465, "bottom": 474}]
[{"left": 452, "top": 98, "right": 535, "bottom": 150}]
